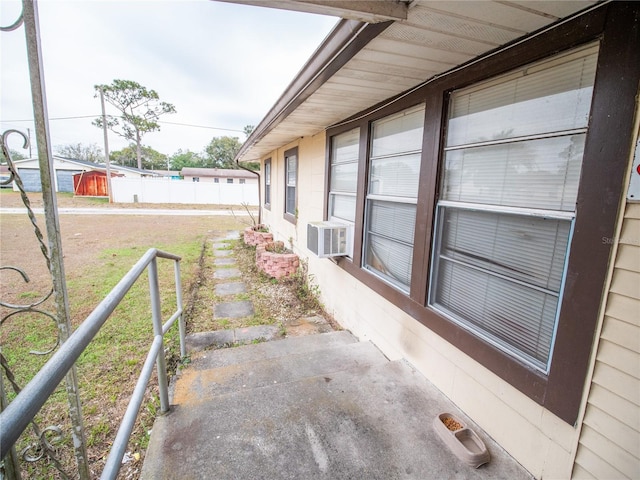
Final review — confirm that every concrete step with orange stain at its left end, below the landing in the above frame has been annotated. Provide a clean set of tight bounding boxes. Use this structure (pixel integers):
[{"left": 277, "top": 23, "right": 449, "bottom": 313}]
[{"left": 172, "top": 342, "right": 388, "bottom": 406}]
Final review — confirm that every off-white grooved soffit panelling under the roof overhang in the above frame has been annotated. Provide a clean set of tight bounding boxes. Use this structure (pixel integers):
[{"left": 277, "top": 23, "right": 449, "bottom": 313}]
[{"left": 238, "top": 0, "right": 598, "bottom": 162}]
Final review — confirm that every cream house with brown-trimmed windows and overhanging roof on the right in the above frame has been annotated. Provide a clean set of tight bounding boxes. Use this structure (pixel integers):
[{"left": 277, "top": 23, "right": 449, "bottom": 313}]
[{"left": 230, "top": 0, "right": 640, "bottom": 478}]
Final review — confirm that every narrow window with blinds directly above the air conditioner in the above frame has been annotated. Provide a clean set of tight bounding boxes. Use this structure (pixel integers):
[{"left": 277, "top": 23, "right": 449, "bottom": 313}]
[{"left": 329, "top": 128, "right": 360, "bottom": 223}]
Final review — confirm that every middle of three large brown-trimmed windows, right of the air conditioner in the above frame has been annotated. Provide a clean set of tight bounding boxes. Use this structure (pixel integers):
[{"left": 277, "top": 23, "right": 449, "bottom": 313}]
[{"left": 363, "top": 105, "right": 425, "bottom": 293}]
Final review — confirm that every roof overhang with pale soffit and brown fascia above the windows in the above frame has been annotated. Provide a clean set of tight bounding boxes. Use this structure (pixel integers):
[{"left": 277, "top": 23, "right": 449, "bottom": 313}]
[{"left": 231, "top": 0, "right": 610, "bottom": 162}]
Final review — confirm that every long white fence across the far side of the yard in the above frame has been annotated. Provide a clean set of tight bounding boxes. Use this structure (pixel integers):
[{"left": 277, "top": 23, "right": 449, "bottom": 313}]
[{"left": 111, "top": 177, "right": 258, "bottom": 206}]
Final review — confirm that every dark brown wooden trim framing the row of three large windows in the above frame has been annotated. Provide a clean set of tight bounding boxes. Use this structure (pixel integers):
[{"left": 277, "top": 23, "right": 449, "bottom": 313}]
[{"left": 327, "top": 2, "right": 640, "bottom": 425}]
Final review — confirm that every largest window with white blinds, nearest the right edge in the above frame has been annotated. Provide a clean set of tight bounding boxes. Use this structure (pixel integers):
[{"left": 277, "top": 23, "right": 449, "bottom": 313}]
[{"left": 429, "top": 46, "right": 597, "bottom": 372}]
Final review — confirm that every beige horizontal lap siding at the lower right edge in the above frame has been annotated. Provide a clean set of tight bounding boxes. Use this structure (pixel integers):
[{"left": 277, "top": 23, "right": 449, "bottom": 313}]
[{"left": 572, "top": 203, "right": 640, "bottom": 479}]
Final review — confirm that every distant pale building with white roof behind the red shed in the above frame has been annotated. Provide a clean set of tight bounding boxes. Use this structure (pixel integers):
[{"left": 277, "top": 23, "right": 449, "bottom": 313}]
[{"left": 13, "top": 155, "right": 159, "bottom": 193}]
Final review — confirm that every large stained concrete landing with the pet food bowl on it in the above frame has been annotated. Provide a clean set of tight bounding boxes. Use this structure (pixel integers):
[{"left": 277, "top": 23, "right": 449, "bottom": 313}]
[{"left": 141, "top": 358, "right": 531, "bottom": 480}]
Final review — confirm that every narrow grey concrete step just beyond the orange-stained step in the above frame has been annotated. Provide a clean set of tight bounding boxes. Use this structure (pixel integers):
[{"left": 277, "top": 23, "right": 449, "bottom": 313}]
[{"left": 189, "top": 330, "right": 358, "bottom": 370}]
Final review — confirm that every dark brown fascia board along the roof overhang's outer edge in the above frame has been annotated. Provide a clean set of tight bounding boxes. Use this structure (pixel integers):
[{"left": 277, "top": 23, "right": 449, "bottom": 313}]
[{"left": 236, "top": 19, "right": 393, "bottom": 161}]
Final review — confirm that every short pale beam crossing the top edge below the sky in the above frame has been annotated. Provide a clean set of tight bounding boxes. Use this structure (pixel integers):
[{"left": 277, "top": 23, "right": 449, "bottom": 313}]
[{"left": 212, "top": 0, "right": 411, "bottom": 23}]
